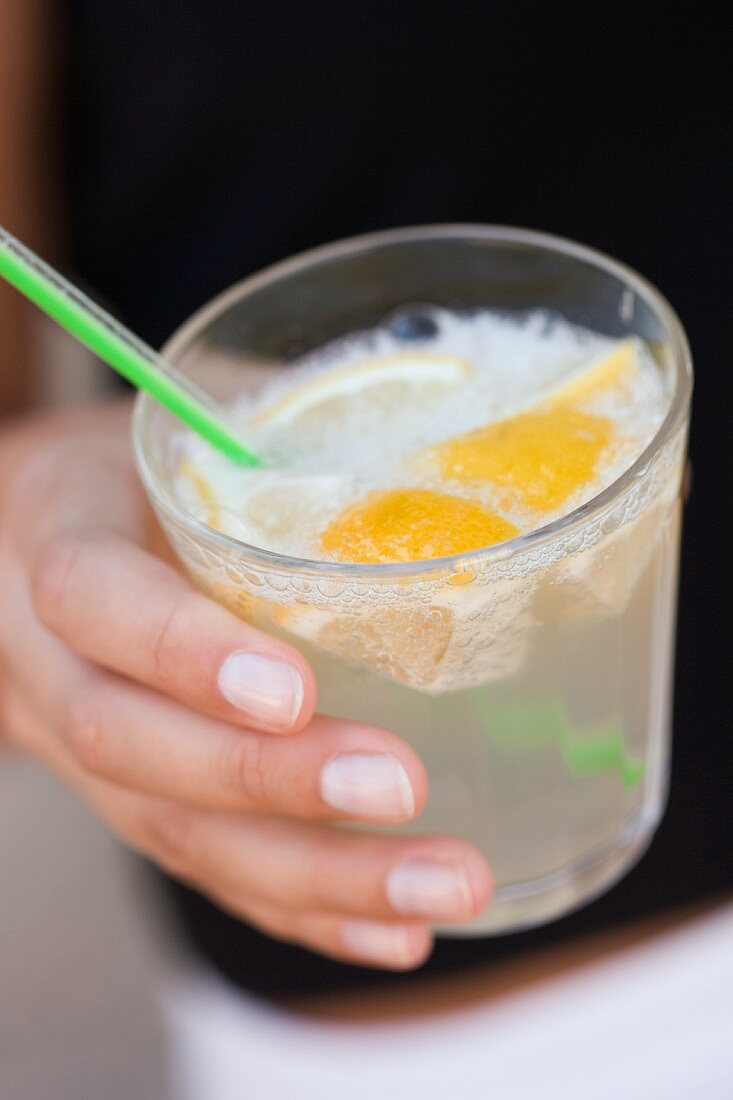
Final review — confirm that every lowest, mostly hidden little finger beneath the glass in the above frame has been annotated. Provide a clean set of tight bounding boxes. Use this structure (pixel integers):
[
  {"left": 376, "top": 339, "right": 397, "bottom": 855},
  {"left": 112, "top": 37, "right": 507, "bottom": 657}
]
[{"left": 215, "top": 894, "right": 433, "bottom": 970}]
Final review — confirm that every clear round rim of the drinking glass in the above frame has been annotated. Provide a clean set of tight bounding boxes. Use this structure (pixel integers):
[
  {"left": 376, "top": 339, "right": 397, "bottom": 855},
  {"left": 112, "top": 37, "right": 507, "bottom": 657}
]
[{"left": 132, "top": 222, "right": 692, "bottom": 581}]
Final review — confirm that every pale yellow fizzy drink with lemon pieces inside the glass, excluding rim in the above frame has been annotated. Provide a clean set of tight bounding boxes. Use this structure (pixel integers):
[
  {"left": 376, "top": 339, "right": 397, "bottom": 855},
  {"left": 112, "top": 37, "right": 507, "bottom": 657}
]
[{"left": 167, "top": 312, "right": 679, "bottom": 932}]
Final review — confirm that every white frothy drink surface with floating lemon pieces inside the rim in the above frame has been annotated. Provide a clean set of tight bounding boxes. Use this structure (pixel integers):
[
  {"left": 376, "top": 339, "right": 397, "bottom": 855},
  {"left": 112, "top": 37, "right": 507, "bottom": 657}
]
[{"left": 177, "top": 306, "right": 668, "bottom": 563}]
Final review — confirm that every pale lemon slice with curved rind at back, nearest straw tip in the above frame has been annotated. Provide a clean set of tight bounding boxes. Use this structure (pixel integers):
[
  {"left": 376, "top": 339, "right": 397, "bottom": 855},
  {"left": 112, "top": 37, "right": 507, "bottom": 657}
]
[{"left": 250, "top": 352, "right": 473, "bottom": 432}]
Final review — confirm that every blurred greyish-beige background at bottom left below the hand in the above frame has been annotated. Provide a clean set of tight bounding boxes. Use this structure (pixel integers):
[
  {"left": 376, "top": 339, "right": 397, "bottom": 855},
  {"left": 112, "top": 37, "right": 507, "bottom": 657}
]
[{"left": 0, "top": 743, "right": 166, "bottom": 1100}]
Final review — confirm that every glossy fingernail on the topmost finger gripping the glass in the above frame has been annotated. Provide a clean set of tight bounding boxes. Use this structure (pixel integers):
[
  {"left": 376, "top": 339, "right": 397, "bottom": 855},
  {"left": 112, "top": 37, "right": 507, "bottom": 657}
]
[{"left": 219, "top": 653, "right": 303, "bottom": 729}]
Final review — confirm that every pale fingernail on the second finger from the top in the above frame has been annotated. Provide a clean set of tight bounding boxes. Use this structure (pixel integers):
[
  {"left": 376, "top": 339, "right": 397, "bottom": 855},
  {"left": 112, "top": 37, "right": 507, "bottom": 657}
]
[{"left": 320, "top": 752, "right": 415, "bottom": 821}]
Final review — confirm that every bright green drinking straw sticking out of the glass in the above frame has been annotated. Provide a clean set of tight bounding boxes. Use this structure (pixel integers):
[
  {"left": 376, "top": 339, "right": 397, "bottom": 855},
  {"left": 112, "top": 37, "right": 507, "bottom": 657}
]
[{"left": 0, "top": 227, "right": 263, "bottom": 466}]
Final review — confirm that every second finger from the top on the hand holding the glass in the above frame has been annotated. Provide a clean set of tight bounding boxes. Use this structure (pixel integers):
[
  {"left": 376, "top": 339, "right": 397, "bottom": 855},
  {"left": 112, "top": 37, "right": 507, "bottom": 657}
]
[{"left": 58, "top": 671, "right": 427, "bottom": 822}]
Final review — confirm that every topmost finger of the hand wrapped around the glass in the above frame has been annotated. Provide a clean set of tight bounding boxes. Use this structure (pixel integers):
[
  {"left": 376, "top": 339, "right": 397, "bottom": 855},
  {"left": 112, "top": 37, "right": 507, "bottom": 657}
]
[{"left": 32, "top": 529, "right": 316, "bottom": 733}]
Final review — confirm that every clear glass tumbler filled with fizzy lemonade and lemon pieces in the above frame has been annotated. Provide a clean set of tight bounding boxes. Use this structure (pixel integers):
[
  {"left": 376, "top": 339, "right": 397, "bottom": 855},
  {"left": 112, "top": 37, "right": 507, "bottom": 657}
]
[{"left": 136, "top": 227, "right": 689, "bottom": 934}]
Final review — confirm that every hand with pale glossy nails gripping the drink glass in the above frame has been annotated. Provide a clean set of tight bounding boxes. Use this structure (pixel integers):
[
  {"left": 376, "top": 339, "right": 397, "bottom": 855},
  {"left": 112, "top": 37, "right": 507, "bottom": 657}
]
[{"left": 0, "top": 408, "right": 491, "bottom": 969}]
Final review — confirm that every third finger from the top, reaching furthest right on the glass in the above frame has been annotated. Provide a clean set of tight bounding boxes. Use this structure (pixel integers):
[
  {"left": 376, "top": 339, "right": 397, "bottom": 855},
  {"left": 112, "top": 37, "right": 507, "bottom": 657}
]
[{"left": 149, "top": 806, "right": 491, "bottom": 922}]
